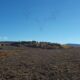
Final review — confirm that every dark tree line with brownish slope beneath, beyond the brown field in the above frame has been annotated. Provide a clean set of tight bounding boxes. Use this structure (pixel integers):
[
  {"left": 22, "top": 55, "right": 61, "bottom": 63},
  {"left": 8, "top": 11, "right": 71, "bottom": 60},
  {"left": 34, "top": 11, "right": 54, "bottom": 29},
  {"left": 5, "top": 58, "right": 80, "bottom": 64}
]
[{"left": 11, "top": 41, "right": 63, "bottom": 49}]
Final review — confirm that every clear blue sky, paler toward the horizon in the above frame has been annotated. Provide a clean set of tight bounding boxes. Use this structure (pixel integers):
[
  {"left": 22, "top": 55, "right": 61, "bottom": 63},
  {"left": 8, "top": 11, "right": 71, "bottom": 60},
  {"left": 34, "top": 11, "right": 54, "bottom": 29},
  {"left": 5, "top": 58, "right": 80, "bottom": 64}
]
[{"left": 0, "top": 0, "right": 80, "bottom": 43}]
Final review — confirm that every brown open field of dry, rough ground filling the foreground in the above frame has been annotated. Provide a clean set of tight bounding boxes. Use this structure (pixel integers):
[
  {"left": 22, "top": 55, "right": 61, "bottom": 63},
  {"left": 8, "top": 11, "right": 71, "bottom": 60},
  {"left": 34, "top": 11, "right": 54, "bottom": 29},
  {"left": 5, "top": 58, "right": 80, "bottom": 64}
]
[{"left": 0, "top": 47, "right": 80, "bottom": 80}]
